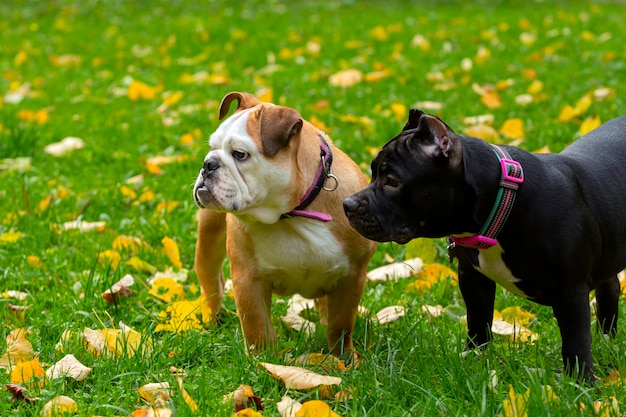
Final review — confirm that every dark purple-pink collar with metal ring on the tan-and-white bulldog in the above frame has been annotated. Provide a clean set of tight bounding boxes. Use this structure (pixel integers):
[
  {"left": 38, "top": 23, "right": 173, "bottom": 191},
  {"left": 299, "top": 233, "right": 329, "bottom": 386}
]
[{"left": 281, "top": 134, "right": 339, "bottom": 222}]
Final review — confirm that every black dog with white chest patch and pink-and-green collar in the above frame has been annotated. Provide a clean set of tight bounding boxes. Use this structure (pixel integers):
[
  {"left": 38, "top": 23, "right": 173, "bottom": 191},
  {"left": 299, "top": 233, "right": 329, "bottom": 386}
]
[{"left": 344, "top": 109, "right": 626, "bottom": 381}]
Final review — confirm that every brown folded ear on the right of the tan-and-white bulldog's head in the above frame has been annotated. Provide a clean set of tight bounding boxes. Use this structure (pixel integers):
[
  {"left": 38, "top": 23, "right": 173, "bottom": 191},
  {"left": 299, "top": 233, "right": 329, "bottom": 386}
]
[{"left": 259, "top": 106, "right": 303, "bottom": 156}]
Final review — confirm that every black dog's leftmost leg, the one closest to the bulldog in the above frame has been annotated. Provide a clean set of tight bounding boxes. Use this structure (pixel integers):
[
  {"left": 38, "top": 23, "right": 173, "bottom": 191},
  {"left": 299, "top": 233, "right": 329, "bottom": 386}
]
[{"left": 459, "top": 259, "right": 496, "bottom": 349}]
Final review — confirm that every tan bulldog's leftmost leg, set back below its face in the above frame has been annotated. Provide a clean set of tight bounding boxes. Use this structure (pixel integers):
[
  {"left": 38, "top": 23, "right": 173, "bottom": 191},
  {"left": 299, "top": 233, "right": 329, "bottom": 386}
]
[{"left": 194, "top": 209, "right": 226, "bottom": 323}]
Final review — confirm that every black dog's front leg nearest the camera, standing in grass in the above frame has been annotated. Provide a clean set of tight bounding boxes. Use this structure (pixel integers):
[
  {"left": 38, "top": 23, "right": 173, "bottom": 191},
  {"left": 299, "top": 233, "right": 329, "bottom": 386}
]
[{"left": 552, "top": 286, "right": 594, "bottom": 382}]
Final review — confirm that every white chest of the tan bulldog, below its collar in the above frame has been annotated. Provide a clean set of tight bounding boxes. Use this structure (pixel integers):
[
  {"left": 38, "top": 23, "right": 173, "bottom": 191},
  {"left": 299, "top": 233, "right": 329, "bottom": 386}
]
[{"left": 249, "top": 218, "right": 349, "bottom": 298}]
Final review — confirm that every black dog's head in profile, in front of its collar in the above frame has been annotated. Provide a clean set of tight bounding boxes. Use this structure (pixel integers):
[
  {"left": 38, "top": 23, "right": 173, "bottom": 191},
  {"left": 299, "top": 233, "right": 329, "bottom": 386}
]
[{"left": 344, "top": 110, "right": 461, "bottom": 243}]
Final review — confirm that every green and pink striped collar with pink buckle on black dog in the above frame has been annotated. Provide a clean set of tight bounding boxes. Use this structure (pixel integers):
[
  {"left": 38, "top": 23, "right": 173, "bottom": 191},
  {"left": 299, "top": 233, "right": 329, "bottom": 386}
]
[{"left": 450, "top": 145, "right": 524, "bottom": 249}]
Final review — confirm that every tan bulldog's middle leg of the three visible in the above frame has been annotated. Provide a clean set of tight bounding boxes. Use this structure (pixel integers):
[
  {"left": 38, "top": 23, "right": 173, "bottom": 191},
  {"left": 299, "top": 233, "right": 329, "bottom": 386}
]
[{"left": 231, "top": 263, "right": 277, "bottom": 354}]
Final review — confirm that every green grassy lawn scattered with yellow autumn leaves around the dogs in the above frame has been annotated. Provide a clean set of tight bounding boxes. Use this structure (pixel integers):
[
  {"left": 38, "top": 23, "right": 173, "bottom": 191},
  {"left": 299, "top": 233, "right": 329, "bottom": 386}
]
[{"left": 0, "top": 0, "right": 626, "bottom": 416}]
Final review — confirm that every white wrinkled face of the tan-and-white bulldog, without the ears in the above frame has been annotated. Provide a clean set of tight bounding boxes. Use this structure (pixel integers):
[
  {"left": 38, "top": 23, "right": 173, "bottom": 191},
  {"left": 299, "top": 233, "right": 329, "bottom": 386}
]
[{"left": 193, "top": 104, "right": 291, "bottom": 223}]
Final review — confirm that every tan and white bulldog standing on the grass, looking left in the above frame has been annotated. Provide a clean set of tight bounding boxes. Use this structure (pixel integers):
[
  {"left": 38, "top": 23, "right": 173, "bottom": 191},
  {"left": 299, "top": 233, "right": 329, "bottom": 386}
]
[{"left": 193, "top": 92, "right": 375, "bottom": 354}]
